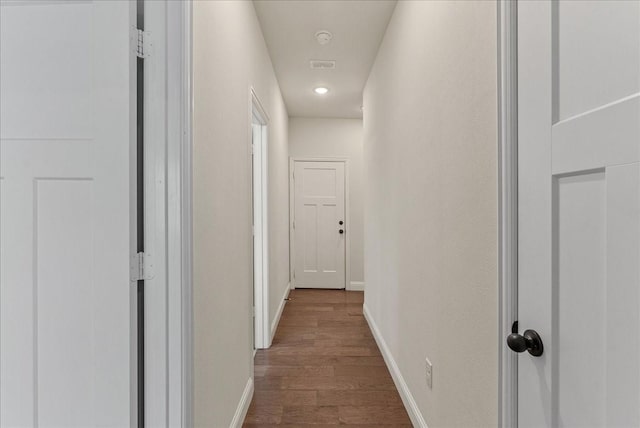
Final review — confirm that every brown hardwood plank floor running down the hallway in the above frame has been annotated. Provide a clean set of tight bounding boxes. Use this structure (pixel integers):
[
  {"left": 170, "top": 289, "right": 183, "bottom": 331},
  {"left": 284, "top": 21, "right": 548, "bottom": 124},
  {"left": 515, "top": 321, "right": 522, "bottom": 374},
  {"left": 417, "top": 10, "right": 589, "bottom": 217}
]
[{"left": 243, "top": 290, "right": 411, "bottom": 428}]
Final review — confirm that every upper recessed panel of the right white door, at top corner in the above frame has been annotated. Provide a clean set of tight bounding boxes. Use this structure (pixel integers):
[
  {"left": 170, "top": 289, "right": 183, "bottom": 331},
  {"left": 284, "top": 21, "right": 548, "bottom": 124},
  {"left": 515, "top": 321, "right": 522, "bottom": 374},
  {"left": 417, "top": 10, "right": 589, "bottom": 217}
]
[{"left": 552, "top": 0, "right": 640, "bottom": 121}]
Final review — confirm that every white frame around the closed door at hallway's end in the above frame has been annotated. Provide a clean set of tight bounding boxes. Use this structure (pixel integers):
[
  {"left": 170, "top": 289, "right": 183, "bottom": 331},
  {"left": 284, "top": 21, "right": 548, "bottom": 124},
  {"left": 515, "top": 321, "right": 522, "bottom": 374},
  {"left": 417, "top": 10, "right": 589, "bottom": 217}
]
[{"left": 289, "top": 156, "right": 353, "bottom": 291}]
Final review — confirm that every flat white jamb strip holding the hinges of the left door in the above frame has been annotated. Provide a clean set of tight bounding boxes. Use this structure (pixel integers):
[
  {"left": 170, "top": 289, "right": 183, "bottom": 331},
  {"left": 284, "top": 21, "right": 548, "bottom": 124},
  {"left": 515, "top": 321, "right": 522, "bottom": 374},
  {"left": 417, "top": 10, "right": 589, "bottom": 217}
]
[{"left": 143, "top": 0, "right": 170, "bottom": 426}]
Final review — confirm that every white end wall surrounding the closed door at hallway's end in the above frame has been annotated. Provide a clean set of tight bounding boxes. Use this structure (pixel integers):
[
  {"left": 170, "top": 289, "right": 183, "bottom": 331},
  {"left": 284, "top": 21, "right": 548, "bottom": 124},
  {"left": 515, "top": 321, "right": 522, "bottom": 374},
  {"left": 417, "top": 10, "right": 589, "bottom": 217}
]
[{"left": 289, "top": 117, "right": 364, "bottom": 282}]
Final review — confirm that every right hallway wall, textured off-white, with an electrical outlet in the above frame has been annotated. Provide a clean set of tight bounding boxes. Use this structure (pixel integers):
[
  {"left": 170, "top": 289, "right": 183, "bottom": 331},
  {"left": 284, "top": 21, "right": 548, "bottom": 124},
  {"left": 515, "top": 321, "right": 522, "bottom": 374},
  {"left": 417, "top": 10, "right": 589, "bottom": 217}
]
[{"left": 364, "top": 1, "right": 498, "bottom": 428}]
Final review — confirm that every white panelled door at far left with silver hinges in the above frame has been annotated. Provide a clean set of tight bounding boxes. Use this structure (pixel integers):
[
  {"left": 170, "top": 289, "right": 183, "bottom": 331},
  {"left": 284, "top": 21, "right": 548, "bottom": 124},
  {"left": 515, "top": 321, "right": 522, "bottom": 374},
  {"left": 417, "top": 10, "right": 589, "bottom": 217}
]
[{"left": 0, "top": 0, "right": 135, "bottom": 427}]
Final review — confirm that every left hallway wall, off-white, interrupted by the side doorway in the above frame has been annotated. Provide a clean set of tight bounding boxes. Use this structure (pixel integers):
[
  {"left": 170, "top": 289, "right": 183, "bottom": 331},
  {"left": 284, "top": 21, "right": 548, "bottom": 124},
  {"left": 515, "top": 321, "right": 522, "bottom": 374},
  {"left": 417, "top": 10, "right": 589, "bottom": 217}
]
[{"left": 193, "top": 1, "right": 289, "bottom": 428}]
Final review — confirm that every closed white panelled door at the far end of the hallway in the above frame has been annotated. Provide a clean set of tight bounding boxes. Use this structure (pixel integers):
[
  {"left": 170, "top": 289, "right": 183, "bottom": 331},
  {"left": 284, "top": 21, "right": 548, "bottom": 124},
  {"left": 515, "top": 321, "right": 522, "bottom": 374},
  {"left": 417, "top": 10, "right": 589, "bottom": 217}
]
[{"left": 293, "top": 161, "right": 349, "bottom": 288}]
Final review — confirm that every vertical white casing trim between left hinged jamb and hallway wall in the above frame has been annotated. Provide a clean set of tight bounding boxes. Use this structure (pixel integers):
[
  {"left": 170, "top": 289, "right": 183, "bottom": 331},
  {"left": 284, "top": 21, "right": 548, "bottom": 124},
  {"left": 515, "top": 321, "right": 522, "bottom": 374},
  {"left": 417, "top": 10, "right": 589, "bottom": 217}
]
[{"left": 166, "top": 1, "right": 193, "bottom": 427}]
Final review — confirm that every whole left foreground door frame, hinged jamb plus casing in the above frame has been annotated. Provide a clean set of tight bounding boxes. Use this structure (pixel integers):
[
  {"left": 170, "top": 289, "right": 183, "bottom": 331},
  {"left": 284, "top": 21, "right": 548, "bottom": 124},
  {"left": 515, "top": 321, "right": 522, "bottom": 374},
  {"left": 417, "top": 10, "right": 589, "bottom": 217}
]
[{"left": 145, "top": 0, "right": 193, "bottom": 427}]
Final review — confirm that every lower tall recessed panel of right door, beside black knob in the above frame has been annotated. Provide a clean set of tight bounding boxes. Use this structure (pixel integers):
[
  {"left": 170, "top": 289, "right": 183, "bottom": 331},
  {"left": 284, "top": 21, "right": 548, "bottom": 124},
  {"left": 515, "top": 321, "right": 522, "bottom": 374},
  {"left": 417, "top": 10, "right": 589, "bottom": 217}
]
[{"left": 548, "top": 172, "right": 607, "bottom": 427}]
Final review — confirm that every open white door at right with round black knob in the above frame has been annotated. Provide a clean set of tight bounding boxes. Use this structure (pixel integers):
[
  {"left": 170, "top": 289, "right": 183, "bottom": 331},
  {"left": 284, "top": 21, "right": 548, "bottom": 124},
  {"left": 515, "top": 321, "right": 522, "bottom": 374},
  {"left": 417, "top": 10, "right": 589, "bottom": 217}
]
[{"left": 518, "top": 0, "right": 640, "bottom": 428}]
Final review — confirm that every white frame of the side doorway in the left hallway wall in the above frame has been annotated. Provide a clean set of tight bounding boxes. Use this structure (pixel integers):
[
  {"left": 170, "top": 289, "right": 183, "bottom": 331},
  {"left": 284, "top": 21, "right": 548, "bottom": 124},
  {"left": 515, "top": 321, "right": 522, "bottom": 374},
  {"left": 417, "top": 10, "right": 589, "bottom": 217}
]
[{"left": 249, "top": 87, "right": 271, "bottom": 350}]
